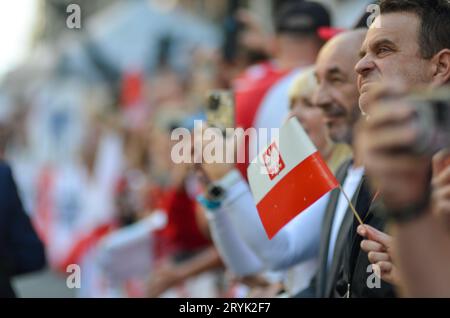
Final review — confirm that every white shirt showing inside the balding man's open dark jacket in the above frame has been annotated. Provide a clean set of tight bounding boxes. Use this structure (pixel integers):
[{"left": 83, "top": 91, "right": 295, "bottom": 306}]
[{"left": 327, "top": 166, "right": 364, "bottom": 267}]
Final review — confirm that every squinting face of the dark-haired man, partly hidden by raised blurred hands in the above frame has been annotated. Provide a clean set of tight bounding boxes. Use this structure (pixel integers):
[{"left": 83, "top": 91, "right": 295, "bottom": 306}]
[{"left": 355, "top": 13, "right": 432, "bottom": 113}]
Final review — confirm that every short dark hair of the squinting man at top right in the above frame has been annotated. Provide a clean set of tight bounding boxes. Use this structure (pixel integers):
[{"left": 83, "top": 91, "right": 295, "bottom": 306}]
[{"left": 379, "top": 0, "right": 450, "bottom": 59}]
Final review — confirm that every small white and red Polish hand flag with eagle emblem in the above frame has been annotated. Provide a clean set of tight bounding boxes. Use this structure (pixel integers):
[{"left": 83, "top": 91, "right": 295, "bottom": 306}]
[{"left": 247, "top": 117, "right": 339, "bottom": 239}]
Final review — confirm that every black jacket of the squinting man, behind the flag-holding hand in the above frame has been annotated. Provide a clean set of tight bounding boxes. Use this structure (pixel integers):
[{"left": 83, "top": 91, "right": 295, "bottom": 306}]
[{"left": 334, "top": 177, "right": 395, "bottom": 298}]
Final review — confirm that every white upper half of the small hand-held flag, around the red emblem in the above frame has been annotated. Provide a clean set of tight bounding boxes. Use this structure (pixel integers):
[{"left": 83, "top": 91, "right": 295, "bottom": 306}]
[{"left": 247, "top": 117, "right": 317, "bottom": 204}]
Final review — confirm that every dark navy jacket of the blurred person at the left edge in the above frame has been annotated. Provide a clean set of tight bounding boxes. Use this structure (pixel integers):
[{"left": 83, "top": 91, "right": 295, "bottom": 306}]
[{"left": 0, "top": 161, "right": 46, "bottom": 297}]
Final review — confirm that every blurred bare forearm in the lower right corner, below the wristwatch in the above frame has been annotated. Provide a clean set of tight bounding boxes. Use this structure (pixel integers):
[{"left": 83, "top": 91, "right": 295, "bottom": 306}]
[{"left": 396, "top": 159, "right": 450, "bottom": 297}]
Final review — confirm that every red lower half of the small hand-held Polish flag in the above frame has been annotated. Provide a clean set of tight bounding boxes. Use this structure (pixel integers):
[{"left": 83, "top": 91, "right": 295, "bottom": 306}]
[{"left": 257, "top": 152, "right": 339, "bottom": 239}]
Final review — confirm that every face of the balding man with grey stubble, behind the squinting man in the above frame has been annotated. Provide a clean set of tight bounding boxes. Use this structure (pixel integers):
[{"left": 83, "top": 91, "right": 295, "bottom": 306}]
[{"left": 313, "top": 30, "right": 365, "bottom": 143}]
